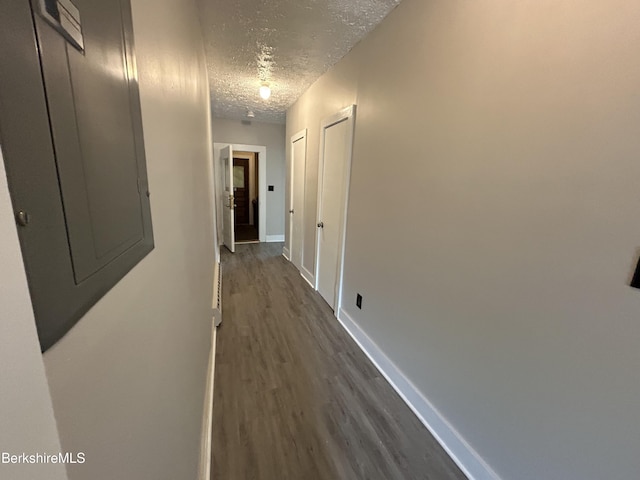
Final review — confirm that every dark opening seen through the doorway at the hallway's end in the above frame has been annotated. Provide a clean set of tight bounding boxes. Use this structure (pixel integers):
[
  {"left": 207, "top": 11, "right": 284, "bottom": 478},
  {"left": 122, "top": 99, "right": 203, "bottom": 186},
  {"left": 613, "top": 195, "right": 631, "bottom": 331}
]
[{"left": 233, "top": 151, "right": 260, "bottom": 243}]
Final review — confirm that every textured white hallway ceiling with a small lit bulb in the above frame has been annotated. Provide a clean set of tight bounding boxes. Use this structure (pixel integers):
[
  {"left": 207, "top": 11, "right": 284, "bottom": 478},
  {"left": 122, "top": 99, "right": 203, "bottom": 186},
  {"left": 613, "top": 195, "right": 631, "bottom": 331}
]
[{"left": 199, "top": 0, "right": 401, "bottom": 123}]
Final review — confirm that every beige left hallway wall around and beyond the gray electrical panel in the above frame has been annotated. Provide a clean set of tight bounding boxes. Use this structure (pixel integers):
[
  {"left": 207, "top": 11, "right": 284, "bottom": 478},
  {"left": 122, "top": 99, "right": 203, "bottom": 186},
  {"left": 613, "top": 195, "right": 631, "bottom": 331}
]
[{"left": 44, "top": 0, "right": 215, "bottom": 480}]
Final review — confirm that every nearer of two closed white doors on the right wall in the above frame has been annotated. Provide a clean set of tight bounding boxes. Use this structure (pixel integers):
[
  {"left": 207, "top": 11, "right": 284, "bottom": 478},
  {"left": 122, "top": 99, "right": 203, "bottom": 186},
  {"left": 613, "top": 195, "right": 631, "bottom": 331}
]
[{"left": 316, "top": 106, "right": 355, "bottom": 311}]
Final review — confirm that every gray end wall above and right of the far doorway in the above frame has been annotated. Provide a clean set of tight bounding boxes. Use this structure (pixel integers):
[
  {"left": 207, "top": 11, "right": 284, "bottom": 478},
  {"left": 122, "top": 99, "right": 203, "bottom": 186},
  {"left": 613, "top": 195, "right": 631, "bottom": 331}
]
[{"left": 213, "top": 118, "right": 285, "bottom": 236}]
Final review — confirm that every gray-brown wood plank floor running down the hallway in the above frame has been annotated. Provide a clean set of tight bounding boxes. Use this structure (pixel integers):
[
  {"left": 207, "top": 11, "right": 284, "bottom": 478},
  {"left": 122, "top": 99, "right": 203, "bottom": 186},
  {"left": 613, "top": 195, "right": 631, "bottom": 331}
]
[{"left": 211, "top": 243, "right": 465, "bottom": 480}]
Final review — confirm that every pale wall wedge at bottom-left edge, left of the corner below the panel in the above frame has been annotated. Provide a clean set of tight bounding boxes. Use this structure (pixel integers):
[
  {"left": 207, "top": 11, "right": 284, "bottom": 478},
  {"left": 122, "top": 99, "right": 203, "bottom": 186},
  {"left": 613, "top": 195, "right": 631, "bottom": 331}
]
[{"left": 0, "top": 150, "right": 67, "bottom": 480}]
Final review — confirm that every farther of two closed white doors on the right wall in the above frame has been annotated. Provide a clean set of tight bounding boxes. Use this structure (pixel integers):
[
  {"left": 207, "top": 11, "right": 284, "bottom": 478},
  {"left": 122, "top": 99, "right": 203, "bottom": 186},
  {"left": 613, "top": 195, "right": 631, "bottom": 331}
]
[{"left": 289, "top": 130, "right": 307, "bottom": 270}]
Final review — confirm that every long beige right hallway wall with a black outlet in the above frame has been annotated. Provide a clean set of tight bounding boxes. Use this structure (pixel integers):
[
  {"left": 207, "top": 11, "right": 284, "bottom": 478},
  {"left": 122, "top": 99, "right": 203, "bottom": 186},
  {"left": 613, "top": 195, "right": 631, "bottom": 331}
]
[{"left": 287, "top": 0, "right": 640, "bottom": 480}]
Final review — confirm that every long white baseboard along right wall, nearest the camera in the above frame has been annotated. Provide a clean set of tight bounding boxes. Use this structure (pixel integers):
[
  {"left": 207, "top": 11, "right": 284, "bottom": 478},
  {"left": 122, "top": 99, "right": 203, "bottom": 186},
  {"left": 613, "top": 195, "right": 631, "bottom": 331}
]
[{"left": 338, "top": 309, "right": 500, "bottom": 480}]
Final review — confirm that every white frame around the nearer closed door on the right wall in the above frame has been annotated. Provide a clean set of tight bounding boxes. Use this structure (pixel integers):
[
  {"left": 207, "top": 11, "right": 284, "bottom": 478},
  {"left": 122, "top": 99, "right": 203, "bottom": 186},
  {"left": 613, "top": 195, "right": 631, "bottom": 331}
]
[{"left": 314, "top": 105, "right": 356, "bottom": 315}]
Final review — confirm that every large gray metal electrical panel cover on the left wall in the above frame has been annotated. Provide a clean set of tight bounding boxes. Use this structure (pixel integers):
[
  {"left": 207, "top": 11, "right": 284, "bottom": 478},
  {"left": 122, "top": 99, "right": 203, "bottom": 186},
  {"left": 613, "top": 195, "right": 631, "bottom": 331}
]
[{"left": 0, "top": 0, "right": 153, "bottom": 351}]
